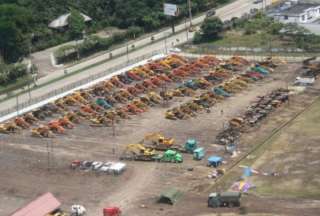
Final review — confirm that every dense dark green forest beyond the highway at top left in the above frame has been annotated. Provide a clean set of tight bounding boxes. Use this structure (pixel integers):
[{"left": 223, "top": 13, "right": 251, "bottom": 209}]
[{"left": 0, "top": 0, "right": 219, "bottom": 62}]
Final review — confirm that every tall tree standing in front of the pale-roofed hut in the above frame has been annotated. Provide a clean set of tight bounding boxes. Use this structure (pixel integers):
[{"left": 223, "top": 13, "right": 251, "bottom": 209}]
[{"left": 68, "top": 10, "right": 86, "bottom": 39}]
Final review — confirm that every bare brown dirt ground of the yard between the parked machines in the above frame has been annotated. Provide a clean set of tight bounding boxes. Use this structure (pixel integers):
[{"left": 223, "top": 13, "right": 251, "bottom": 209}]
[{"left": 0, "top": 61, "right": 319, "bottom": 216}]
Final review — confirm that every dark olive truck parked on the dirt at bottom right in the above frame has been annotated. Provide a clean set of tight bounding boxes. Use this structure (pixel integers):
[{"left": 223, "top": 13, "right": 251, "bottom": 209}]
[{"left": 208, "top": 191, "right": 241, "bottom": 208}]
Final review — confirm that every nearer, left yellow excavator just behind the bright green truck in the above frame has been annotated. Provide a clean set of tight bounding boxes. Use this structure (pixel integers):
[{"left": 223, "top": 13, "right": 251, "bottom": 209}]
[{"left": 120, "top": 144, "right": 157, "bottom": 161}]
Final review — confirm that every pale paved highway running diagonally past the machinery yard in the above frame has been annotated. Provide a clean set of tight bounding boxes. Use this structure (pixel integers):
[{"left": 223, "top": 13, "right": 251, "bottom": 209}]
[{"left": 0, "top": 0, "right": 271, "bottom": 117}]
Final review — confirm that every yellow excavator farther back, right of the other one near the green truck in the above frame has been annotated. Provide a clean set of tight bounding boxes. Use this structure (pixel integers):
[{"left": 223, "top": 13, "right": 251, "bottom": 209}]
[{"left": 141, "top": 133, "right": 179, "bottom": 151}]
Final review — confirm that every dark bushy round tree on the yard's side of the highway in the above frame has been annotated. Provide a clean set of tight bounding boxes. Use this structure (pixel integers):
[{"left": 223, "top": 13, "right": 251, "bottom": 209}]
[{"left": 201, "top": 17, "right": 223, "bottom": 41}]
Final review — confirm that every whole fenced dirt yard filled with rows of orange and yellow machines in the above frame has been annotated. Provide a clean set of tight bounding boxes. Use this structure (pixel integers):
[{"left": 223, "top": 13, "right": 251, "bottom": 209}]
[{"left": 0, "top": 51, "right": 320, "bottom": 216}]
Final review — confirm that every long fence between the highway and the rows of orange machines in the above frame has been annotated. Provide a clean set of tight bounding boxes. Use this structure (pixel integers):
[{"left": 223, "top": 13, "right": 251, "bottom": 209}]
[{"left": 0, "top": 49, "right": 164, "bottom": 117}]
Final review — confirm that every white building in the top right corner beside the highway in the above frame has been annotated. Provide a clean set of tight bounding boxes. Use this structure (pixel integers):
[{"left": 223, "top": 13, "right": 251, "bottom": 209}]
[{"left": 272, "top": 2, "right": 320, "bottom": 24}]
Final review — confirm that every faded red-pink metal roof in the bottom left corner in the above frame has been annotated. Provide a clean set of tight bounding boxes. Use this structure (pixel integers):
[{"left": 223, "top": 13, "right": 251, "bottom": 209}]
[{"left": 11, "top": 193, "right": 61, "bottom": 216}]
